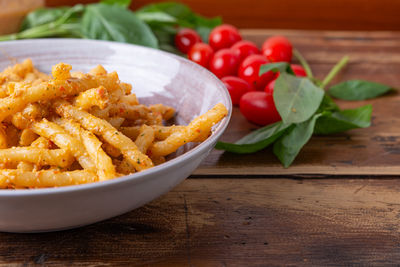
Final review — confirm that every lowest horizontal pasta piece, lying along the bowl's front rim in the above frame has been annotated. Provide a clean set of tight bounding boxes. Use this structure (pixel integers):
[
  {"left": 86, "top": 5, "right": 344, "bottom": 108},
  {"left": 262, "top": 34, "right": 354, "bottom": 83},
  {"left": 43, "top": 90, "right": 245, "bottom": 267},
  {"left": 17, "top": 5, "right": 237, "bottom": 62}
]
[{"left": 0, "top": 169, "right": 98, "bottom": 188}]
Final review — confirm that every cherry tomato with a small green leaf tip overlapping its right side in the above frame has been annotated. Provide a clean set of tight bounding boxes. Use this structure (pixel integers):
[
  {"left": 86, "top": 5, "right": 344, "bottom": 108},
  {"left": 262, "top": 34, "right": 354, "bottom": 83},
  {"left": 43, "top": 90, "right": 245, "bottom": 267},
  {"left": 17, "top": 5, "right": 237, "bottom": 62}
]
[{"left": 238, "top": 55, "right": 275, "bottom": 90}]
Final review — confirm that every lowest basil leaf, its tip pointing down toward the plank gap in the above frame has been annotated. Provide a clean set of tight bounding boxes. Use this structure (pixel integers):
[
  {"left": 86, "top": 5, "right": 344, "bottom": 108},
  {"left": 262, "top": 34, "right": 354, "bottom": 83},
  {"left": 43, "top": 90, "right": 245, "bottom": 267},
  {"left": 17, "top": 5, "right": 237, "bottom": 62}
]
[{"left": 274, "top": 114, "right": 321, "bottom": 168}]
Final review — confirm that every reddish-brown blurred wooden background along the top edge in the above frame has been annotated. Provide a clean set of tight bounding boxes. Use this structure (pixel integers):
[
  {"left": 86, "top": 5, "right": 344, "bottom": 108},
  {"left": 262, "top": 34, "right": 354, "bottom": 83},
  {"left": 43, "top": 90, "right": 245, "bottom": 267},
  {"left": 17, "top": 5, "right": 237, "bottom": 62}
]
[{"left": 46, "top": 0, "right": 400, "bottom": 30}]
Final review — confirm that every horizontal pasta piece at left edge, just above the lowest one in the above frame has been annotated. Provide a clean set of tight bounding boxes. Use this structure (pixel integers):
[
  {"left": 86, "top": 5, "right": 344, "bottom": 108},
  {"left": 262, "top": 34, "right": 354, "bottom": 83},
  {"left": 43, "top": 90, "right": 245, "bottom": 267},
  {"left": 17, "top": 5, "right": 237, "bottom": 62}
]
[{"left": 0, "top": 147, "right": 74, "bottom": 168}]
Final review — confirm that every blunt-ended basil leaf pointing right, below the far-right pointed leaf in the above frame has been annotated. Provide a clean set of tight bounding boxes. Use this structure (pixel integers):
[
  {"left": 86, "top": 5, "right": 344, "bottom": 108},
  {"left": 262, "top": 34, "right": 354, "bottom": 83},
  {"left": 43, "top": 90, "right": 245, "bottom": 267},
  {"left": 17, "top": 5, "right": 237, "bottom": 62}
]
[{"left": 314, "top": 105, "right": 372, "bottom": 134}]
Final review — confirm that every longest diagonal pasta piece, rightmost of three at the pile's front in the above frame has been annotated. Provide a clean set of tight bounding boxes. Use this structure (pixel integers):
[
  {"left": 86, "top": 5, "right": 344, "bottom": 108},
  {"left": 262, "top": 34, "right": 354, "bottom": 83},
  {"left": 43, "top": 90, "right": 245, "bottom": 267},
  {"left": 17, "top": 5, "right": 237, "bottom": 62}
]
[{"left": 54, "top": 100, "right": 154, "bottom": 171}]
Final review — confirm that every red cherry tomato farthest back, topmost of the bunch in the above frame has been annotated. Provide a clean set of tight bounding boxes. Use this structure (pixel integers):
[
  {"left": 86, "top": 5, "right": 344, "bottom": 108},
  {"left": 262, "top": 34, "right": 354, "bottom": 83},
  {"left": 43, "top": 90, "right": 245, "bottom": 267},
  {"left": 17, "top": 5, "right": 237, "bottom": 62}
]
[{"left": 208, "top": 24, "right": 242, "bottom": 51}]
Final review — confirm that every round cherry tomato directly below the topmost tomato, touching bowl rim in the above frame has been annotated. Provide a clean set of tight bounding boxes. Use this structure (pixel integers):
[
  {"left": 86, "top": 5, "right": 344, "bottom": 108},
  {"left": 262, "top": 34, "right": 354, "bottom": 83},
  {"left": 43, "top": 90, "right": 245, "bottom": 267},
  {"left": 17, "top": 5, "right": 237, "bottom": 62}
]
[{"left": 210, "top": 48, "right": 239, "bottom": 78}]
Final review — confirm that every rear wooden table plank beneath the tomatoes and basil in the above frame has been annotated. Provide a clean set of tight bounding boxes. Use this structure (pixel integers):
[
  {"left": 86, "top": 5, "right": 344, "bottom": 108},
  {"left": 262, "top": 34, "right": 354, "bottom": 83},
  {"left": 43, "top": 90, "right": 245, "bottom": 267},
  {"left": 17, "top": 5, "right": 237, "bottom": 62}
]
[{"left": 194, "top": 30, "right": 400, "bottom": 175}]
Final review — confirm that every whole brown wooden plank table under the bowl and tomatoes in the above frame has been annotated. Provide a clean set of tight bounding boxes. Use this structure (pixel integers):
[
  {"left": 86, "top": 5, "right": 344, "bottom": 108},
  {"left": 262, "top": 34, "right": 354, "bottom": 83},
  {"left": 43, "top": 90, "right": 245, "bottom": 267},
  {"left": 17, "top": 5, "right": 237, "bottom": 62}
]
[{"left": 0, "top": 30, "right": 400, "bottom": 266}]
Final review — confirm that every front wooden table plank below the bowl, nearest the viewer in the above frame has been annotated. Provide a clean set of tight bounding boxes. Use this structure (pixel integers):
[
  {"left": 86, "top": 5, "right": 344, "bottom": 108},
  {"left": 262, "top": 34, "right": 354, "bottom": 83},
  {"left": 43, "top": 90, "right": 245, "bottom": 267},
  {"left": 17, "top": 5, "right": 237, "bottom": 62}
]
[{"left": 0, "top": 179, "right": 400, "bottom": 266}]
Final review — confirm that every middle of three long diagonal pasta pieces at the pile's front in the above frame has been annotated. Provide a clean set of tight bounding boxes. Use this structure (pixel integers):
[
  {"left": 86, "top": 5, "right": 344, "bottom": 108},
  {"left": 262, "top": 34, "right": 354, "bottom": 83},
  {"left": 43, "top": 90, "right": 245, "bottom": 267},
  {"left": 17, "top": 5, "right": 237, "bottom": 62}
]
[{"left": 55, "top": 119, "right": 116, "bottom": 181}]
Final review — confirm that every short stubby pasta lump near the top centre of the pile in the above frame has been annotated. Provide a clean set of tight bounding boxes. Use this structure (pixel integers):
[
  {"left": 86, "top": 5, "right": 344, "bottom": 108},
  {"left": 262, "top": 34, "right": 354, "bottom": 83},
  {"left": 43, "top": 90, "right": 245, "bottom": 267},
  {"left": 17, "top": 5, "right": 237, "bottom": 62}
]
[{"left": 74, "top": 86, "right": 109, "bottom": 110}]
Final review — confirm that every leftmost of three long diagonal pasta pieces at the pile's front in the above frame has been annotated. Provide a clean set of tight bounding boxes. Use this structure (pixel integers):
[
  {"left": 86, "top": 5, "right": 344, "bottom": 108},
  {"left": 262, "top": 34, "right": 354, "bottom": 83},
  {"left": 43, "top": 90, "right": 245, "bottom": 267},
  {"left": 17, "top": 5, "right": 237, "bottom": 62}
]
[{"left": 32, "top": 119, "right": 95, "bottom": 170}]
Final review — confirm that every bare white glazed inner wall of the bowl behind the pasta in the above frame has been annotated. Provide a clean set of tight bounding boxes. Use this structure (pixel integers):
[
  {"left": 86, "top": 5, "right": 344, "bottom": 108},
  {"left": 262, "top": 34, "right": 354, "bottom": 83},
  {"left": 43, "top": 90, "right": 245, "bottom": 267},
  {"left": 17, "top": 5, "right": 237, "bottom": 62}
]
[{"left": 0, "top": 39, "right": 231, "bottom": 161}]
